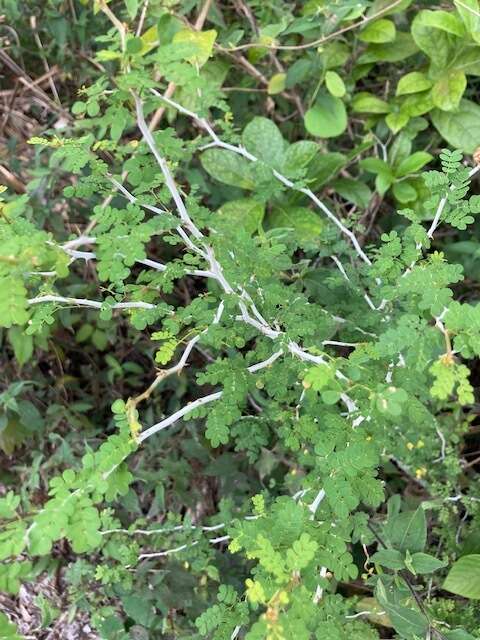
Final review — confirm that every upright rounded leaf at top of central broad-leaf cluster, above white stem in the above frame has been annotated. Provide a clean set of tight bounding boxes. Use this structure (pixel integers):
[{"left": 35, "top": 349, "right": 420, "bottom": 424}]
[{"left": 242, "top": 116, "right": 285, "bottom": 167}]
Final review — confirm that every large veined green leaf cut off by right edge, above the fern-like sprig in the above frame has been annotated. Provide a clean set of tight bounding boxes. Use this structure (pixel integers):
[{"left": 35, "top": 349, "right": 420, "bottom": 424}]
[{"left": 431, "top": 99, "right": 480, "bottom": 153}]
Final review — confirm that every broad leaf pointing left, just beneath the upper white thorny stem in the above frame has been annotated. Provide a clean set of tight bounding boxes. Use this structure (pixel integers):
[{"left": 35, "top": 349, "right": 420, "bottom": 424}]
[{"left": 201, "top": 149, "right": 255, "bottom": 189}]
